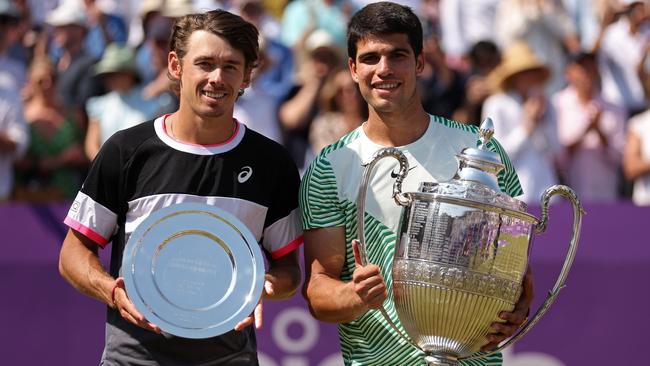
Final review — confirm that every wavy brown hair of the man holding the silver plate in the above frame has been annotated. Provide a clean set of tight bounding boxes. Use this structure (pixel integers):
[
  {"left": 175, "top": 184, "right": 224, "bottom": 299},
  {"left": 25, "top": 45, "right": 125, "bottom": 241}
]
[{"left": 169, "top": 9, "right": 259, "bottom": 91}]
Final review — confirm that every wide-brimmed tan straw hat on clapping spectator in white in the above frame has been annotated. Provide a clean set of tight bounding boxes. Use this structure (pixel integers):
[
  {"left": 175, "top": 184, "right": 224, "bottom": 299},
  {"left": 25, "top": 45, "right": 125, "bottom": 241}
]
[{"left": 488, "top": 42, "right": 551, "bottom": 91}]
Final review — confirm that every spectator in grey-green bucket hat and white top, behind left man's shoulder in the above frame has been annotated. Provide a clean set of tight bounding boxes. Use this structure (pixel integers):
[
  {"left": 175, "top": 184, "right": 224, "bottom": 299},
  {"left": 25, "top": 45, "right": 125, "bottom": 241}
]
[{"left": 85, "top": 43, "right": 159, "bottom": 160}]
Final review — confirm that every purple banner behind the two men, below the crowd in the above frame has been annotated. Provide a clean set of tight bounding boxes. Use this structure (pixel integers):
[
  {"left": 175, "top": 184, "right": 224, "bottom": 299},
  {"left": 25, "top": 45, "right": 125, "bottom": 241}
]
[{"left": 0, "top": 204, "right": 650, "bottom": 366}]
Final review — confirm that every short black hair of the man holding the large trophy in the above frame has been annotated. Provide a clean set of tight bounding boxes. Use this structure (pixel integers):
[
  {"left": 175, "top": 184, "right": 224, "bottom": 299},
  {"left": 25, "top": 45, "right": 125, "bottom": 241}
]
[{"left": 348, "top": 1, "right": 422, "bottom": 59}]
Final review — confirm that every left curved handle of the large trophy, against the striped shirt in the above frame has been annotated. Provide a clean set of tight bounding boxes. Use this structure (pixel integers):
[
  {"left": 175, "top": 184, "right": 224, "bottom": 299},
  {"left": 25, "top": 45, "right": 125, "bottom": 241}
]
[{"left": 357, "top": 147, "right": 410, "bottom": 347}]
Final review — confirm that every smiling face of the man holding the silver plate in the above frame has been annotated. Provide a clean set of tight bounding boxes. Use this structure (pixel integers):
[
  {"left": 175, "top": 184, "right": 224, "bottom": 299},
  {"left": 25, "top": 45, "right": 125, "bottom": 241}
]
[{"left": 168, "top": 30, "right": 251, "bottom": 120}]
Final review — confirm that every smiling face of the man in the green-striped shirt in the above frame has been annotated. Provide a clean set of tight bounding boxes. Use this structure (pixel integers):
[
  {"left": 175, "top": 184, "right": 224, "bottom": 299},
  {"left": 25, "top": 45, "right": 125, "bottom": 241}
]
[{"left": 348, "top": 33, "right": 424, "bottom": 113}]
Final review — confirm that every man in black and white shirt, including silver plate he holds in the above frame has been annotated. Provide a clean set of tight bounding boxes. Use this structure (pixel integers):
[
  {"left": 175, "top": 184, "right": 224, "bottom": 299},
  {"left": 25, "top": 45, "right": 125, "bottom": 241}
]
[{"left": 59, "top": 10, "right": 302, "bottom": 365}]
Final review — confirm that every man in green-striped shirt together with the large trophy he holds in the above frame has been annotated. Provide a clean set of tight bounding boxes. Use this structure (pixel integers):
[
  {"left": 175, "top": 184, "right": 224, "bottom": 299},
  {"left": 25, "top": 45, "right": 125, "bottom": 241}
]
[{"left": 300, "top": 2, "right": 581, "bottom": 366}]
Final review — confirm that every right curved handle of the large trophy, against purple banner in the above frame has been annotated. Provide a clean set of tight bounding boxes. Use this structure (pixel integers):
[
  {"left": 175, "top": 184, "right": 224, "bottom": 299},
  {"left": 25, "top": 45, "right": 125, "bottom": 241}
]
[{"left": 463, "top": 184, "right": 585, "bottom": 360}]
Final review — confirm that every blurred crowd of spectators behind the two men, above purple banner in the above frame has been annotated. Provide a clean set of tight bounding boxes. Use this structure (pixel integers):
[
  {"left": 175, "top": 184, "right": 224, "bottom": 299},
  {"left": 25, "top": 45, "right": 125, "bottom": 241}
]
[{"left": 0, "top": 0, "right": 650, "bottom": 205}]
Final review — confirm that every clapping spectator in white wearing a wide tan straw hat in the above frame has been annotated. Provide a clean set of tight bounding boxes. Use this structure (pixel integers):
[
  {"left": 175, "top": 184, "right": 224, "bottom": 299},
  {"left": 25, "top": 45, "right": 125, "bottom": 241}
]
[{"left": 483, "top": 42, "right": 561, "bottom": 203}]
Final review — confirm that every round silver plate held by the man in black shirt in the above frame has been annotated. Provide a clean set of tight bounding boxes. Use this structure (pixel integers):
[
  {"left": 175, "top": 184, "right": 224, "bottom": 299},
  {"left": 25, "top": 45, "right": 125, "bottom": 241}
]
[{"left": 122, "top": 203, "right": 264, "bottom": 338}]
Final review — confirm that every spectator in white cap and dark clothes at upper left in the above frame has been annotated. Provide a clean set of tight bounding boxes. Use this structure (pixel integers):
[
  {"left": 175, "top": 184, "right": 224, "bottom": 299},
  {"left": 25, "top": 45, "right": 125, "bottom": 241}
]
[{"left": 45, "top": 0, "right": 101, "bottom": 111}]
